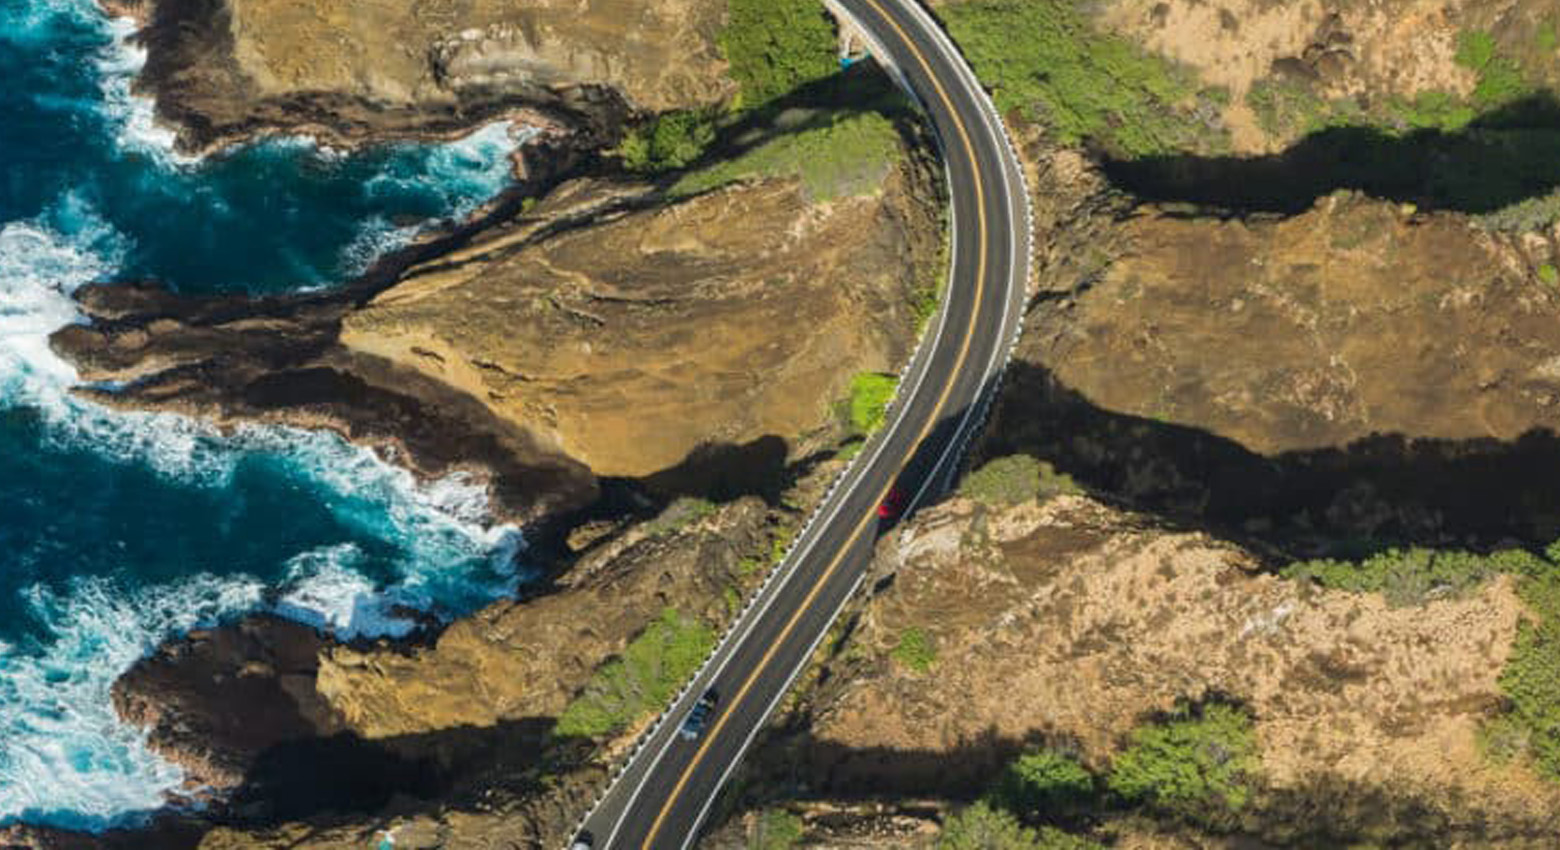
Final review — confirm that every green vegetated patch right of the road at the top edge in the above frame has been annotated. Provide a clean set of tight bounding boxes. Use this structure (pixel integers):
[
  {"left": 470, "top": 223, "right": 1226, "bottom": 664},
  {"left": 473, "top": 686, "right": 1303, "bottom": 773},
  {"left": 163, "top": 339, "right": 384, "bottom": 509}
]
[{"left": 938, "top": 0, "right": 1228, "bottom": 158}]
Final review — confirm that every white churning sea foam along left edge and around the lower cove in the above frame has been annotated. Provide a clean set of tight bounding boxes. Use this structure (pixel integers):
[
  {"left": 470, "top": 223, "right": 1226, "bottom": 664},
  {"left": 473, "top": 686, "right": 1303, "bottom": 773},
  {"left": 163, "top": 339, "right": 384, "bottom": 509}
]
[{"left": 0, "top": 198, "right": 523, "bottom": 828}]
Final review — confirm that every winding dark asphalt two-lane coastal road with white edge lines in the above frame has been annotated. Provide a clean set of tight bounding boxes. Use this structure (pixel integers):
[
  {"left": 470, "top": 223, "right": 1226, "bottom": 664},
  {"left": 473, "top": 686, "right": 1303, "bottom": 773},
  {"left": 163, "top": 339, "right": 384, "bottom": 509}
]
[{"left": 585, "top": 0, "right": 1030, "bottom": 850}]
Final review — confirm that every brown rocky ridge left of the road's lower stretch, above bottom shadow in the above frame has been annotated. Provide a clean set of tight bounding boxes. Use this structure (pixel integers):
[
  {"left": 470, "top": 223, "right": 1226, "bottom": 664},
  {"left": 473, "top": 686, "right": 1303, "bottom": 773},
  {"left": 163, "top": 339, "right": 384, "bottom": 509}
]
[{"left": 318, "top": 499, "right": 766, "bottom": 738}]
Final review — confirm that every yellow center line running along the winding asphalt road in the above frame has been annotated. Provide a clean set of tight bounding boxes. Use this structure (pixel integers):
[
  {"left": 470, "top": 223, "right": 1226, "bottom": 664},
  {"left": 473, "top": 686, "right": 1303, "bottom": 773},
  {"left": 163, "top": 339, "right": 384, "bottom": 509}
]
[{"left": 639, "top": 0, "right": 987, "bottom": 850}]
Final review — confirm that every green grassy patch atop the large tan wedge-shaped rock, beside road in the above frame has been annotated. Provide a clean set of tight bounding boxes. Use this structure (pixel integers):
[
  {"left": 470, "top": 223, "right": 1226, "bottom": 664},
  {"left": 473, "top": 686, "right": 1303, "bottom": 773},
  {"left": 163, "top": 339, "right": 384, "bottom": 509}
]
[{"left": 671, "top": 112, "right": 902, "bottom": 201}]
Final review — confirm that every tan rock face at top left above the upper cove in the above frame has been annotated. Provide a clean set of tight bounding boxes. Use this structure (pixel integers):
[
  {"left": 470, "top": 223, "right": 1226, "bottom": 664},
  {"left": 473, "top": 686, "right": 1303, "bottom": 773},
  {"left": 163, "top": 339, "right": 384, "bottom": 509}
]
[{"left": 108, "top": 0, "right": 730, "bottom": 148}]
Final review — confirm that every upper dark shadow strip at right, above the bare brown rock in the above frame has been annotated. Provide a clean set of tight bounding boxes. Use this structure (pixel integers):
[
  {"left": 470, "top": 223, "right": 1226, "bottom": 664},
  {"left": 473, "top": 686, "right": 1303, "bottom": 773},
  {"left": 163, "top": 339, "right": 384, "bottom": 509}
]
[{"left": 1104, "top": 92, "right": 1560, "bottom": 214}]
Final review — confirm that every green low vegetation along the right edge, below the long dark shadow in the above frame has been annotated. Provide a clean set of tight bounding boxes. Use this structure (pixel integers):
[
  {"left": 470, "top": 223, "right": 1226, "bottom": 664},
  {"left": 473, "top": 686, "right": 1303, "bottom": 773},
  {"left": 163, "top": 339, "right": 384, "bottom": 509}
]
[{"left": 1284, "top": 544, "right": 1560, "bottom": 781}]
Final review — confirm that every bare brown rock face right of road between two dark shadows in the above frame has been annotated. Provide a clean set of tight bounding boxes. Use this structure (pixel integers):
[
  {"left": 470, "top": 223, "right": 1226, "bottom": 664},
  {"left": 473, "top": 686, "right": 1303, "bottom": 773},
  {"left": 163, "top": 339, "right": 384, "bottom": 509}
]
[{"left": 1026, "top": 193, "right": 1560, "bottom": 454}]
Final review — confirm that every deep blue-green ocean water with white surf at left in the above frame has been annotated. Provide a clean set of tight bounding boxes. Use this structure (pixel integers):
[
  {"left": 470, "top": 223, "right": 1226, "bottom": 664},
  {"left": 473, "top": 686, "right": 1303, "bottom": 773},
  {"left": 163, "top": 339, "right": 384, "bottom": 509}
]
[{"left": 0, "top": 0, "right": 523, "bottom": 830}]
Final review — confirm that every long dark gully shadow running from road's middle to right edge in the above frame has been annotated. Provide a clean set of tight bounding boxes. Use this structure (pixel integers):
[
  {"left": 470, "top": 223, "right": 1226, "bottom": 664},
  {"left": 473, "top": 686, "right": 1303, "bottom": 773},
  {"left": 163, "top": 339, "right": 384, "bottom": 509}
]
[{"left": 977, "top": 360, "right": 1560, "bottom": 557}]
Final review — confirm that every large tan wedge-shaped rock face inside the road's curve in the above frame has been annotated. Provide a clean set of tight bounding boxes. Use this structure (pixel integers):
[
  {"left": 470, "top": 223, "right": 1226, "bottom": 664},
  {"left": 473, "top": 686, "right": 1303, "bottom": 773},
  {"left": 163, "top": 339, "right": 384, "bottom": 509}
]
[{"left": 342, "top": 167, "right": 936, "bottom": 477}]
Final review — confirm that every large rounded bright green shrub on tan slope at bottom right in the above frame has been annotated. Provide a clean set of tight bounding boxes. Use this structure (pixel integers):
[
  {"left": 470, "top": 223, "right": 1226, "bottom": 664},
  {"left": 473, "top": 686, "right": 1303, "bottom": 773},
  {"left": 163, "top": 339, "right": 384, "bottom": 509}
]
[{"left": 1108, "top": 703, "right": 1257, "bottom": 825}]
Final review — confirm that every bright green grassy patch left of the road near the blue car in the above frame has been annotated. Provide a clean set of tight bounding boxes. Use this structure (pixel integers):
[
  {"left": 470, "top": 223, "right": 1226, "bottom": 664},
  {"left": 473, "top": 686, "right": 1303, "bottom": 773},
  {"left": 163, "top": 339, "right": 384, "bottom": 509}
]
[{"left": 554, "top": 608, "right": 714, "bottom": 738}]
